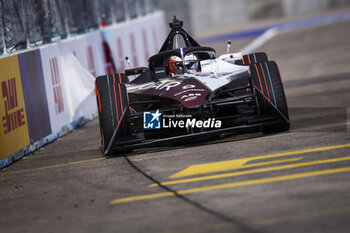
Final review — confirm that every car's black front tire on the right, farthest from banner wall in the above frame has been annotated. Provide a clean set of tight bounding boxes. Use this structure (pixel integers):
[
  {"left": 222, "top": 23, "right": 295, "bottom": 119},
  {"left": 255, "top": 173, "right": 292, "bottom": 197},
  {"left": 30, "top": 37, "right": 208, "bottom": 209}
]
[{"left": 250, "top": 61, "right": 290, "bottom": 133}]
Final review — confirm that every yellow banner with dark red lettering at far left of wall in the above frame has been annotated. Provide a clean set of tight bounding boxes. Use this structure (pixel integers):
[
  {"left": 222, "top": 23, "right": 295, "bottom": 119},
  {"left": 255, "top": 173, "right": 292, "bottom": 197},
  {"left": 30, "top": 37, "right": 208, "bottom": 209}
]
[{"left": 0, "top": 56, "right": 29, "bottom": 159}]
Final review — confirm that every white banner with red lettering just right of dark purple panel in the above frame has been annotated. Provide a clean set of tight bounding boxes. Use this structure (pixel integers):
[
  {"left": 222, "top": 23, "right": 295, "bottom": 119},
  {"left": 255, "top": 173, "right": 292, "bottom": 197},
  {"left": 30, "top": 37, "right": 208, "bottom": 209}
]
[{"left": 40, "top": 44, "right": 71, "bottom": 132}]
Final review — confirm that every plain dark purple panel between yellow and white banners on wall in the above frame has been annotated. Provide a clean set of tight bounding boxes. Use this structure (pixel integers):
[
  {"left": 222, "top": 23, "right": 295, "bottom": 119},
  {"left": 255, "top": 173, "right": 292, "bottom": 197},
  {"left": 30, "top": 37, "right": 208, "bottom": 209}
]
[{"left": 18, "top": 50, "right": 51, "bottom": 144}]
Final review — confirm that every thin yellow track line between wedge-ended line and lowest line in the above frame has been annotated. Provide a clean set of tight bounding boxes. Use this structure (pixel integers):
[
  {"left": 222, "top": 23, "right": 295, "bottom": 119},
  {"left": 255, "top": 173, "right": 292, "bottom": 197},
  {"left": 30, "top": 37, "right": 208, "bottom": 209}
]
[{"left": 148, "top": 156, "right": 350, "bottom": 187}]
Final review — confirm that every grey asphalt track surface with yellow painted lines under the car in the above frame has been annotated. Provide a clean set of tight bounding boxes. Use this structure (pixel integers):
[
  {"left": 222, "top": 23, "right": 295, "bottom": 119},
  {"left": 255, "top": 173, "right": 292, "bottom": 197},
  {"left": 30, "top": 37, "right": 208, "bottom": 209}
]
[{"left": 0, "top": 21, "right": 350, "bottom": 233}]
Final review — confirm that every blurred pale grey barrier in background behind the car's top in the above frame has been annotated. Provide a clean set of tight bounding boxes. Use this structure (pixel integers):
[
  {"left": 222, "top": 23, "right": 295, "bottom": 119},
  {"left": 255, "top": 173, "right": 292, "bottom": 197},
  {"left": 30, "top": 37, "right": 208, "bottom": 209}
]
[{"left": 155, "top": 0, "right": 350, "bottom": 36}]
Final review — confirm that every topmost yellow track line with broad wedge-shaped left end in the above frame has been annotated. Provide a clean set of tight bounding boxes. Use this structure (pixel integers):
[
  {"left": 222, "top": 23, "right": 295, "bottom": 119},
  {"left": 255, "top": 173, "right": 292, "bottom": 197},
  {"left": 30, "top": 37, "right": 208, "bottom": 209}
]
[{"left": 170, "top": 144, "right": 350, "bottom": 178}]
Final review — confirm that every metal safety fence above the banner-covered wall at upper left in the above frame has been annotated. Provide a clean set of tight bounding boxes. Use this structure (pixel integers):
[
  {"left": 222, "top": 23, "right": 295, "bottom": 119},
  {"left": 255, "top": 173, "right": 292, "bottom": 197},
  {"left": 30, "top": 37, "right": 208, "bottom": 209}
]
[{"left": 0, "top": 0, "right": 155, "bottom": 55}]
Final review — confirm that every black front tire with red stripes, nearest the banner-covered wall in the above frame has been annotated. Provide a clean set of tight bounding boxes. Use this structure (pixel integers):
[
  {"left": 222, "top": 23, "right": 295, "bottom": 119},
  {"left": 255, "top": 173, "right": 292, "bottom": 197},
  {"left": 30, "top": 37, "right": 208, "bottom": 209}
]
[{"left": 95, "top": 74, "right": 131, "bottom": 154}]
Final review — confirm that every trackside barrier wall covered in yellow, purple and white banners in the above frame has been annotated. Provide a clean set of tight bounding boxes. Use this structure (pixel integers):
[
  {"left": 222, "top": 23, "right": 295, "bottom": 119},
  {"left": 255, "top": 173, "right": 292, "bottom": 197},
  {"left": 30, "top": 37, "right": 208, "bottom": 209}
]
[{"left": 0, "top": 12, "right": 166, "bottom": 169}]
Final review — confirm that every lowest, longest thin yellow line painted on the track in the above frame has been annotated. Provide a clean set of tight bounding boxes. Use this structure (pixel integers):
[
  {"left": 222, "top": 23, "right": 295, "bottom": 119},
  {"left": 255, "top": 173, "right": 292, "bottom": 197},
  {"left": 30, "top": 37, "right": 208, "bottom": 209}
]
[{"left": 110, "top": 167, "right": 350, "bottom": 204}]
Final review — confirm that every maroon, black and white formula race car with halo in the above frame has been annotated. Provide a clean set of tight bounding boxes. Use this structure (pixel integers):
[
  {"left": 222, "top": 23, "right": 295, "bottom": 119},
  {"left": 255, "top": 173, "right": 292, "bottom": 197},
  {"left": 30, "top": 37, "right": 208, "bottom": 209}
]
[{"left": 95, "top": 18, "right": 290, "bottom": 155}]
